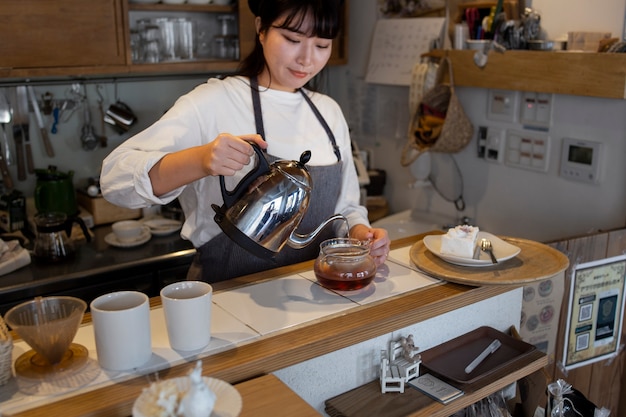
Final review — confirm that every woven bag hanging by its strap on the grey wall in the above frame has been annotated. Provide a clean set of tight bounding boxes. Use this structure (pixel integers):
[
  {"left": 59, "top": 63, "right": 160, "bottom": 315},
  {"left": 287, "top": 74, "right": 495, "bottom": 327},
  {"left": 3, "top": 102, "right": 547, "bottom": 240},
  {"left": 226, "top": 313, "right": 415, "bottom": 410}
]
[{"left": 401, "top": 56, "right": 474, "bottom": 166}]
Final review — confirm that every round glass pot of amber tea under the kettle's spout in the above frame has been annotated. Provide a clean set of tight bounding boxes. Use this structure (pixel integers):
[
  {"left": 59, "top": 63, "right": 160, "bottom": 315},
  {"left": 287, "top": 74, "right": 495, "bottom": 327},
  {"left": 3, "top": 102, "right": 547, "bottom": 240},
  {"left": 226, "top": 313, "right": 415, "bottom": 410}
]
[{"left": 313, "top": 238, "right": 376, "bottom": 291}]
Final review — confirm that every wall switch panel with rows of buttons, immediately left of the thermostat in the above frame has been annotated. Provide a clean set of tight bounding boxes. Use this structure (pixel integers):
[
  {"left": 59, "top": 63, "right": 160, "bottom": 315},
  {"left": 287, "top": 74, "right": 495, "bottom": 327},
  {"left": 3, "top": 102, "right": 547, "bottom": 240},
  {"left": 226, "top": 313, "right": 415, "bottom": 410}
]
[{"left": 504, "top": 130, "right": 550, "bottom": 172}]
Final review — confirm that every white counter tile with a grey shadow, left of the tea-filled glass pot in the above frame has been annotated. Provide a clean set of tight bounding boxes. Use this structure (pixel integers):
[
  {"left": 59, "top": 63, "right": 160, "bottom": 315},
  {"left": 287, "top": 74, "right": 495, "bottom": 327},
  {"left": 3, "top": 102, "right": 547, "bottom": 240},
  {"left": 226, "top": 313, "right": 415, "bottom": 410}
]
[{"left": 213, "top": 275, "right": 356, "bottom": 334}]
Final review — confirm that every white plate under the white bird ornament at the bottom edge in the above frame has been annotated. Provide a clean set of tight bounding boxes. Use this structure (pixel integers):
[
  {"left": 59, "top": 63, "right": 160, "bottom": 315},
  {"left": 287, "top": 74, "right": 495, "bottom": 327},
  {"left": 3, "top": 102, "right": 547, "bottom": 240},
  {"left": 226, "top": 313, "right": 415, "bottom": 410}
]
[{"left": 133, "top": 376, "right": 243, "bottom": 417}]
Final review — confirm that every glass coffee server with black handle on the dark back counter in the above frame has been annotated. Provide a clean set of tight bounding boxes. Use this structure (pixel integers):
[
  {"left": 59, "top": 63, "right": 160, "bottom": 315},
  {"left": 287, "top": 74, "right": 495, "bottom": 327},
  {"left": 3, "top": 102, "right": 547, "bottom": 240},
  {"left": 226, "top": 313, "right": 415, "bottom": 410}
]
[{"left": 33, "top": 212, "right": 91, "bottom": 262}]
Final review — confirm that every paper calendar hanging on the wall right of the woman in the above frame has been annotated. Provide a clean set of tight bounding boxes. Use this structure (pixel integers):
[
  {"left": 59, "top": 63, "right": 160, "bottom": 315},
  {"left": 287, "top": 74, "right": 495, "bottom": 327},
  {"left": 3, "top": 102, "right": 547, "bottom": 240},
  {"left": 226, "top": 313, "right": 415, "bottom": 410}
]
[{"left": 365, "top": 17, "right": 445, "bottom": 86}]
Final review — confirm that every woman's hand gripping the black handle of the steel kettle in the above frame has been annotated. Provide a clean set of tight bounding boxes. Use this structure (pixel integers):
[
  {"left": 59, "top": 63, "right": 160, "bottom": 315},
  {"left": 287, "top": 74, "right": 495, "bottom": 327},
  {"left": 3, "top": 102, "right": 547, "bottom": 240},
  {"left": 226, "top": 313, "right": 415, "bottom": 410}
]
[{"left": 201, "top": 133, "right": 267, "bottom": 176}]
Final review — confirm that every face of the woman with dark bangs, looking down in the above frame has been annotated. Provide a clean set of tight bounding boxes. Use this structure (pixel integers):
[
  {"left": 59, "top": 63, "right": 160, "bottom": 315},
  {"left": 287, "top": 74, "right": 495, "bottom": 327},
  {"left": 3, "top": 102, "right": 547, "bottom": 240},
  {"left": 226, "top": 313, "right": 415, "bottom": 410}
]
[{"left": 257, "top": 12, "right": 332, "bottom": 91}]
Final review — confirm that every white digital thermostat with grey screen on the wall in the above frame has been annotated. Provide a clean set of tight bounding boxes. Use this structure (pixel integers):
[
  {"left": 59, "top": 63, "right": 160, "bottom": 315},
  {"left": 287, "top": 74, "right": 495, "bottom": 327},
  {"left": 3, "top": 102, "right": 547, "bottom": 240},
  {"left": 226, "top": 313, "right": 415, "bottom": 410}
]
[{"left": 560, "top": 138, "right": 602, "bottom": 184}]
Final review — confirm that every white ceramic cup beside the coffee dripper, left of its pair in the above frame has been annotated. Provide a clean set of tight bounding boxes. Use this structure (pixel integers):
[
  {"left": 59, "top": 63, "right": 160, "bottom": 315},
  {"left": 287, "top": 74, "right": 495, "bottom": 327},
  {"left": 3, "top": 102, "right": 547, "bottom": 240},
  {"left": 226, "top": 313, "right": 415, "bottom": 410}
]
[{"left": 90, "top": 291, "right": 152, "bottom": 371}]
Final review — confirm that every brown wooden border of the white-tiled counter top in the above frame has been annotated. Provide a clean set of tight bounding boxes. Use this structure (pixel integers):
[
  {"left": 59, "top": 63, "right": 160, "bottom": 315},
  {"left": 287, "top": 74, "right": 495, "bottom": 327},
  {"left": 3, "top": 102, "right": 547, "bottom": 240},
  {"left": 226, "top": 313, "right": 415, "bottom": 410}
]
[{"left": 4, "top": 237, "right": 512, "bottom": 417}]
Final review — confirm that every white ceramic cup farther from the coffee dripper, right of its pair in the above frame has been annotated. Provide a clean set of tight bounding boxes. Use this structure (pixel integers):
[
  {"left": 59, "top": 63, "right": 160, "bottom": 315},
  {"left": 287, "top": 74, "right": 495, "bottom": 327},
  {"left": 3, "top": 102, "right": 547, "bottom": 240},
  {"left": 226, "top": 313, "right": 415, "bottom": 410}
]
[{"left": 161, "top": 281, "right": 213, "bottom": 351}]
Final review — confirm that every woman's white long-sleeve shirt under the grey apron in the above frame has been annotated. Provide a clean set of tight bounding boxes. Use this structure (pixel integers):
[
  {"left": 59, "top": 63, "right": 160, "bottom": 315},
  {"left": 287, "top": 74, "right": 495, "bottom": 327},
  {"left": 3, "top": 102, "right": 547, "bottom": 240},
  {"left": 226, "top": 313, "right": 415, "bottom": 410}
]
[{"left": 100, "top": 76, "right": 369, "bottom": 247}]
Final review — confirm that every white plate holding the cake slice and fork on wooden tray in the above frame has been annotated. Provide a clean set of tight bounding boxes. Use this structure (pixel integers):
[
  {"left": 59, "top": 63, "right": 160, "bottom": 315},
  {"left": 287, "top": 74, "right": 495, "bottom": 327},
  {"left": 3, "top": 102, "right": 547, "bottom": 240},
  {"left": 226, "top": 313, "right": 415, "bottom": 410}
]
[{"left": 424, "top": 232, "right": 520, "bottom": 267}]
